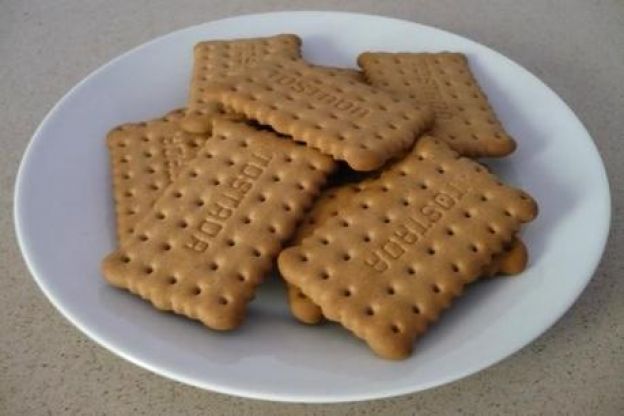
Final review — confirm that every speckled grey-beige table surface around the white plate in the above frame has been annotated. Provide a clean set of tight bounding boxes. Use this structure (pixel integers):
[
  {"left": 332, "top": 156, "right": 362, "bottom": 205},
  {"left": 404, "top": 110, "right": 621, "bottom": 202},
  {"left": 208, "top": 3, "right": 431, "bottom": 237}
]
[{"left": 0, "top": 0, "right": 624, "bottom": 415}]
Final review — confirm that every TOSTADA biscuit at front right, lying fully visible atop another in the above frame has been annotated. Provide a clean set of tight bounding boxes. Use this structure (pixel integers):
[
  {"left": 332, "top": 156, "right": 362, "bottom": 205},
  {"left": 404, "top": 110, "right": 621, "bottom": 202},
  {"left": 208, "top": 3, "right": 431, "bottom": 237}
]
[{"left": 278, "top": 137, "right": 537, "bottom": 359}]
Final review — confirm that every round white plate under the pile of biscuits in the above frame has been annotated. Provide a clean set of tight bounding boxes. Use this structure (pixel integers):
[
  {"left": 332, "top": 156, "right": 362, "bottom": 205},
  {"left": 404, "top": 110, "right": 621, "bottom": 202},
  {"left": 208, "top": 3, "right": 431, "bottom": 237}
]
[{"left": 15, "top": 12, "right": 610, "bottom": 402}]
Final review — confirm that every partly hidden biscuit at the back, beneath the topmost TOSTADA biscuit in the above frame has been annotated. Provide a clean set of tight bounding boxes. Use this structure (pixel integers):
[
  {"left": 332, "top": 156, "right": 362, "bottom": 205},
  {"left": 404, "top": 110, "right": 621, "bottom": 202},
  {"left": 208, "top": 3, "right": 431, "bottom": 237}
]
[{"left": 183, "top": 34, "right": 301, "bottom": 133}]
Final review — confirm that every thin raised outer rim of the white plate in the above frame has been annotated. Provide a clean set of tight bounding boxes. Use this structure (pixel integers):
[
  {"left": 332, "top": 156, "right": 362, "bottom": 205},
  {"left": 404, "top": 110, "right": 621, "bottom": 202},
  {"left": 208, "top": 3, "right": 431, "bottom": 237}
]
[{"left": 13, "top": 10, "right": 612, "bottom": 403}]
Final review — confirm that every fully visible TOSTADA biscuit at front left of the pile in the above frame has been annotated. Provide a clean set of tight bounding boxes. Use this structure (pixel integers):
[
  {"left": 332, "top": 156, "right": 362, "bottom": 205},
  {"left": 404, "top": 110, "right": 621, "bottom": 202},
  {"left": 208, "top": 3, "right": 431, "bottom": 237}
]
[{"left": 102, "top": 119, "right": 335, "bottom": 330}]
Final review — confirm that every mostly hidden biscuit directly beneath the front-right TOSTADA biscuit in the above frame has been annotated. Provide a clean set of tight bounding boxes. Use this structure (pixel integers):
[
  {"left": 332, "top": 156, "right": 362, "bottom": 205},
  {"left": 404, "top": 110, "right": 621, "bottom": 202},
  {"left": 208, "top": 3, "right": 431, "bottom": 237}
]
[{"left": 286, "top": 180, "right": 528, "bottom": 324}]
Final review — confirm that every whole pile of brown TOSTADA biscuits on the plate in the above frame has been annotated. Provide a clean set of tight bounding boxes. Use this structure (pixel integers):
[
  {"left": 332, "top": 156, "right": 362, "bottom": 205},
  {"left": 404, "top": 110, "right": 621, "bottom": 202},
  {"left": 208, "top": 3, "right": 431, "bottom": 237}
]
[{"left": 102, "top": 34, "right": 537, "bottom": 359}]
